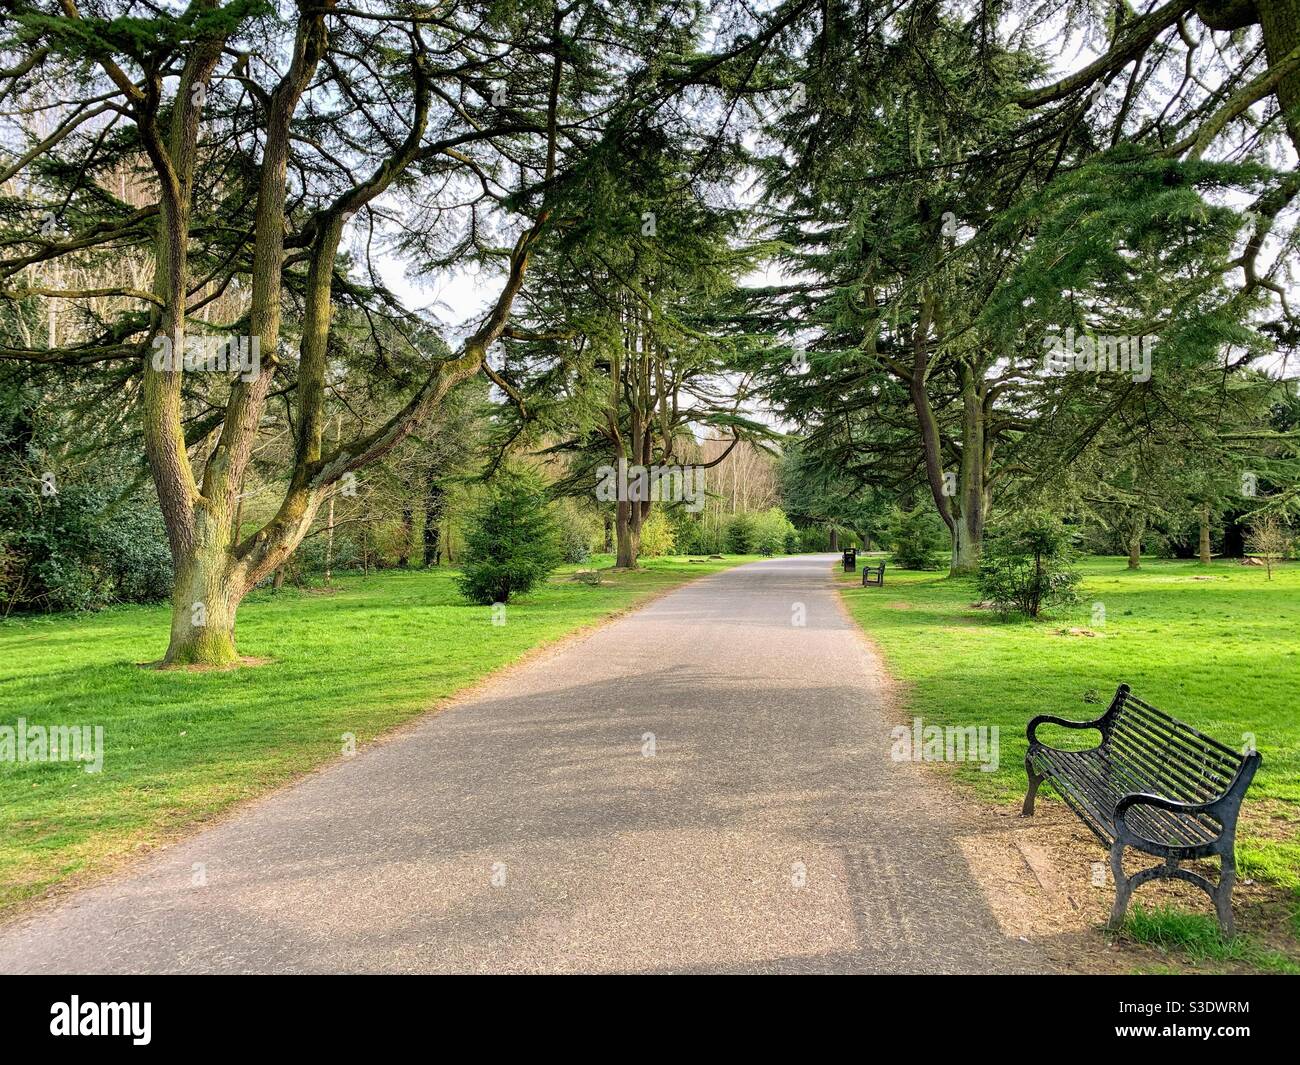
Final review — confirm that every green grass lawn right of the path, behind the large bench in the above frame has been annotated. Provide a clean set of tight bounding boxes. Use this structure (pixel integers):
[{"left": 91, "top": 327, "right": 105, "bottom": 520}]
[{"left": 841, "top": 558, "right": 1300, "bottom": 892}]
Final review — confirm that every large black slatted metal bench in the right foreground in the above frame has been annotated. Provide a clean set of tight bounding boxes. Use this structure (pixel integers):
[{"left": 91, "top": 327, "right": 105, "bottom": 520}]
[{"left": 1024, "top": 684, "right": 1260, "bottom": 935}]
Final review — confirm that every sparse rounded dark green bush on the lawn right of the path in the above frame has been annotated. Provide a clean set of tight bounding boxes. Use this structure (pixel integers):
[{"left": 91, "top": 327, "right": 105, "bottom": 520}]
[{"left": 979, "top": 511, "right": 1079, "bottom": 618}]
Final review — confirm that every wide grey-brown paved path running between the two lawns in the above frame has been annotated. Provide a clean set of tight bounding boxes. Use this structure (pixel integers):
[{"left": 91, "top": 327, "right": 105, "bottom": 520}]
[{"left": 0, "top": 555, "right": 1052, "bottom": 973}]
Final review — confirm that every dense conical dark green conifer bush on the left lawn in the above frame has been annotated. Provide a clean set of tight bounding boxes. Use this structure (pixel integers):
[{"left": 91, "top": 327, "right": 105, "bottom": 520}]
[{"left": 456, "top": 469, "right": 562, "bottom": 605}]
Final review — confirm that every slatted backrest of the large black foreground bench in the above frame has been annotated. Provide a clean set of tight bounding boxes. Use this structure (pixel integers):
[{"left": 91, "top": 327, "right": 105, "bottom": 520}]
[{"left": 1104, "top": 684, "right": 1258, "bottom": 802}]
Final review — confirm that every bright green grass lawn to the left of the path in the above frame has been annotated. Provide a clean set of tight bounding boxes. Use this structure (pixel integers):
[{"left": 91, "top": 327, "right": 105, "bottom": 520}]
[{"left": 0, "top": 557, "right": 745, "bottom": 914}]
